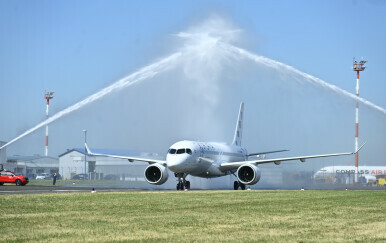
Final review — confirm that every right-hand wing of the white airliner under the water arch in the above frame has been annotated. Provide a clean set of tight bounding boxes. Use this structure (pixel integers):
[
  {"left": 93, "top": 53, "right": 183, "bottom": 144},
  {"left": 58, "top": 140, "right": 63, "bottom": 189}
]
[{"left": 220, "top": 143, "right": 366, "bottom": 170}]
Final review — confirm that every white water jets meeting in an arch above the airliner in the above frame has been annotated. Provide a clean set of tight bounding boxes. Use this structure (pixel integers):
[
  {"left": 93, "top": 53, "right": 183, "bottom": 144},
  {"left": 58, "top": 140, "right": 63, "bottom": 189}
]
[{"left": 0, "top": 20, "right": 386, "bottom": 152}]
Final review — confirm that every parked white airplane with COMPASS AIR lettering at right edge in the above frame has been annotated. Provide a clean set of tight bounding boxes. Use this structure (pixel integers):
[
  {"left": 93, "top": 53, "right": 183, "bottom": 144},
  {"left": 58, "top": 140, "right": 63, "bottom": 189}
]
[{"left": 314, "top": 165, "right": 386, "bottom": 183}]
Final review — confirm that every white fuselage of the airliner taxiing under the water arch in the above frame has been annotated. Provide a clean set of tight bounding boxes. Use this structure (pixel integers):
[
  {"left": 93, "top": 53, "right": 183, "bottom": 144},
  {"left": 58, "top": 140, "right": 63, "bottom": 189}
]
[{"left": 166, "top": 141, "right": 247, "bottom": 178}]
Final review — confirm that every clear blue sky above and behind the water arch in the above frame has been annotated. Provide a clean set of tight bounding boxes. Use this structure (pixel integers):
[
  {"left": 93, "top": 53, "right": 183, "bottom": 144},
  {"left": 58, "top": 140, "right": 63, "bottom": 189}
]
[{"left": 0, "top": 1, "right": 386, "bottom": 167}]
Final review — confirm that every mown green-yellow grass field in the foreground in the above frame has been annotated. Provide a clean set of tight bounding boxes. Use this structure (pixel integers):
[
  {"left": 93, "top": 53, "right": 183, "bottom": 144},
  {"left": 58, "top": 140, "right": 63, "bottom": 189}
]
[{"left": 0, "top": 191, "right": 386, "bottom": 242}]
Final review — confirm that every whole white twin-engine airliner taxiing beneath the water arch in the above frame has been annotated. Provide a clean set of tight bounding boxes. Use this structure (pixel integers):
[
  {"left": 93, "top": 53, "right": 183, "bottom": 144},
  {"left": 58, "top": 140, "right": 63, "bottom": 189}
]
[{"left": 85, "top": 102, "right": 364, "bottom": 190}]
